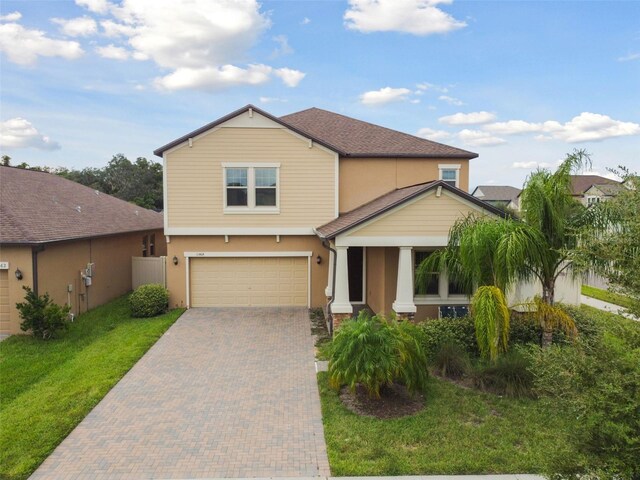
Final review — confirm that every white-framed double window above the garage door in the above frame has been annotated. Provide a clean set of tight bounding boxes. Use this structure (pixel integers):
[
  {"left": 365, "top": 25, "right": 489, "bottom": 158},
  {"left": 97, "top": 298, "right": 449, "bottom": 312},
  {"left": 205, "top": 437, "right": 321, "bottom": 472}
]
[{"left": 223, "top": 163, "right": 280, "bottom": 213}]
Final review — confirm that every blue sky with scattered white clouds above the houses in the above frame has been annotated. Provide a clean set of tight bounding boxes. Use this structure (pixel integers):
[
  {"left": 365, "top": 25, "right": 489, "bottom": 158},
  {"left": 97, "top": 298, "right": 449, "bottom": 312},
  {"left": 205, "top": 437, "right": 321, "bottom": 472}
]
[{"left": 0, "top": 0, "right": 640, "bottom": 186}]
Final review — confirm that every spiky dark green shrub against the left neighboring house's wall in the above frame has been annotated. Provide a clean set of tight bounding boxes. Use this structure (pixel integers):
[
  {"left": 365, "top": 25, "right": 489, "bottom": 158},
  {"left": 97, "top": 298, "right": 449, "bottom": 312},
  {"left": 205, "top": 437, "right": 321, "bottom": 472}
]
[{"left": 16, "top": 286, "right": 71, "bottom": 340}]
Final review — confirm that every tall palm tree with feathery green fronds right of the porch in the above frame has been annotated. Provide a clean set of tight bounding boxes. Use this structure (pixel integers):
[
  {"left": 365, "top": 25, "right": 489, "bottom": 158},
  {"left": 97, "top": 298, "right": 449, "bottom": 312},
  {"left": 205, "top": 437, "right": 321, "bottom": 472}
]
[{"left": 416, "top": 150, "right": 591, "bottom": 346}]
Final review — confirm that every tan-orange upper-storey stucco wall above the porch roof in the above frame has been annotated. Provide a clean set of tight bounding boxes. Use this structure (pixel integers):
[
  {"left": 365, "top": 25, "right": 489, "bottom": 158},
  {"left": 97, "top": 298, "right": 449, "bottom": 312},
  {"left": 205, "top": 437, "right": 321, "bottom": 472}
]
[{"left": 340, "top": 158, "right": 469, "bottom": 212}]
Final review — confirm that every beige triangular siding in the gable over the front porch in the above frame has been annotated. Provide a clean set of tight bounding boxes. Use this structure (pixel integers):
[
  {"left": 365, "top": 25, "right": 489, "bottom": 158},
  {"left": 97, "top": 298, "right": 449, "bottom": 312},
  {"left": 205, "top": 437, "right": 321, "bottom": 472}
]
[{"left": 351, "top": 191, "right": 477, "bottom": 237}]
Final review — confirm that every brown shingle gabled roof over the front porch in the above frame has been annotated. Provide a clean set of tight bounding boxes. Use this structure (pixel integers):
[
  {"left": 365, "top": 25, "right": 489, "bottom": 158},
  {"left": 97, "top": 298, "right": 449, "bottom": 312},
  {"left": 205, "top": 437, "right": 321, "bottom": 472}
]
[{"left": 316, "top": 180, "right": 506, "bottom": 238}]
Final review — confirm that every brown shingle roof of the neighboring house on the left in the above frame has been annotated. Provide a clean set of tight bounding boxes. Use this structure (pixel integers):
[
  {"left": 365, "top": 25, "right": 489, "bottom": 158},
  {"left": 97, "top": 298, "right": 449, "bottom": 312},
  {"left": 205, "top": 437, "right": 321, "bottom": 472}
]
[{"left": 0, "top": 166, "right": 163, "bottom": 244}]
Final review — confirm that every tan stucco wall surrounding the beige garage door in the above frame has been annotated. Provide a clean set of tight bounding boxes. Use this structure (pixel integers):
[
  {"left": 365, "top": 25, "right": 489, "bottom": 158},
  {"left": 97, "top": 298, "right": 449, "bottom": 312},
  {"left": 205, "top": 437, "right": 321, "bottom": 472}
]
[{"left": 167, "top": 235, "right": 329, "bottom": 308}]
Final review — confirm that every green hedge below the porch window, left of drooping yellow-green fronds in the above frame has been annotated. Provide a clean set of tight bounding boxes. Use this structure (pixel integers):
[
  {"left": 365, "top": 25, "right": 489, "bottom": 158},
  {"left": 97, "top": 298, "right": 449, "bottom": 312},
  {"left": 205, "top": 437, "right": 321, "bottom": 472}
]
[{"left": 420, "top": 317, "right": 479, "bottom": 361}]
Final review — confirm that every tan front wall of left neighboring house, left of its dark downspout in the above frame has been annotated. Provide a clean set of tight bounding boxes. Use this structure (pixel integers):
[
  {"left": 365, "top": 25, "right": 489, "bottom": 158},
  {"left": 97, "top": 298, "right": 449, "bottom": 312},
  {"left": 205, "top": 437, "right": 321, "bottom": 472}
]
[{"left": 0, "top": 245, "right": 33, "bottom": 334}]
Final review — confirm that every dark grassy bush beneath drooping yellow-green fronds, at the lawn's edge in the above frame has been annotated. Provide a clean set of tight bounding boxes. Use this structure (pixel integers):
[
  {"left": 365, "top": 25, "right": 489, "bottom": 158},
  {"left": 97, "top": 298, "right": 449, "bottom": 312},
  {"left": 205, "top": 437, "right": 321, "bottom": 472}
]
[{"left": 472, "top": 350, "right": 533, "bottom": 397}]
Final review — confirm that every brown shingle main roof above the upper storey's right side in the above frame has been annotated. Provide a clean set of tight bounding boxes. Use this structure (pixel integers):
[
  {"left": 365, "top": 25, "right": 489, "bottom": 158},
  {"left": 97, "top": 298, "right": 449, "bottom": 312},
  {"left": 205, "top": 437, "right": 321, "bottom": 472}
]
[{"left": 280, "top": 108, "right": 478, "bottom": 159}]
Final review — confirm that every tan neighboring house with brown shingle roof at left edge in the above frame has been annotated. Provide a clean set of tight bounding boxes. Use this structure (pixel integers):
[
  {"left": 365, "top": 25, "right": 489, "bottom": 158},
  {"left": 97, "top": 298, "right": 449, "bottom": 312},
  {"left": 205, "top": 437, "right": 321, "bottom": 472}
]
[{"left": 0, "top": 166, "right": 166, "bottom": 335}]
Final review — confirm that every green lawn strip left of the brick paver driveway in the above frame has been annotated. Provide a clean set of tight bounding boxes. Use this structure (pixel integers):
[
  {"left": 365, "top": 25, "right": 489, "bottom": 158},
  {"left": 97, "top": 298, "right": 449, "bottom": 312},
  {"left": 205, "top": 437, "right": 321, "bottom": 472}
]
[{"left": 0, "top": 296, "right": 183, "bottom": 479}]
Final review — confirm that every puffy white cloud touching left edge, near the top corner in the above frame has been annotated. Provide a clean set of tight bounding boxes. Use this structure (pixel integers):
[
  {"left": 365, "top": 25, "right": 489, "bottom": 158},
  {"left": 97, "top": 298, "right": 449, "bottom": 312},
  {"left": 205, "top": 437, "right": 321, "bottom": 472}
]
[{"left": 0, "top": 23, "right": 84, "bottom": 65}]
